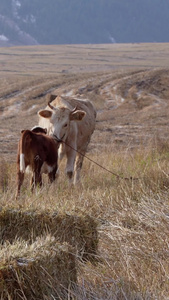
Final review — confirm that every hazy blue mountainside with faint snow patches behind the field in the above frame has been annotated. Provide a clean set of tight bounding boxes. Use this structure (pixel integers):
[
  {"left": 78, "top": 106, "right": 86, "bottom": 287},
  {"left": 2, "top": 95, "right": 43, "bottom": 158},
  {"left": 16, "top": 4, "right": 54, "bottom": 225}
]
[{"left": 0, "top": 0, "right": 169, "bottom": 46}]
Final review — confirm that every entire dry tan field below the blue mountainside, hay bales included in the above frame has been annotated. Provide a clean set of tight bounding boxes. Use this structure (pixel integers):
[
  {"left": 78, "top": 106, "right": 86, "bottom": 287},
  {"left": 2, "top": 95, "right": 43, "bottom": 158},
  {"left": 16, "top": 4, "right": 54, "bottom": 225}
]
[{"left": 0, "top": 44, "right": 169, "bottom": 300}]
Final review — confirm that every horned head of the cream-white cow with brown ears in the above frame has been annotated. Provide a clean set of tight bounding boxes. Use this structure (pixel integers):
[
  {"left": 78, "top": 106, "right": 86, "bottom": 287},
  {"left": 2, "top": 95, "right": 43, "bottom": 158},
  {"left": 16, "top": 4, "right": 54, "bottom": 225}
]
[{"left": 38, "top": 97, "right": 86, "bottom": 141}]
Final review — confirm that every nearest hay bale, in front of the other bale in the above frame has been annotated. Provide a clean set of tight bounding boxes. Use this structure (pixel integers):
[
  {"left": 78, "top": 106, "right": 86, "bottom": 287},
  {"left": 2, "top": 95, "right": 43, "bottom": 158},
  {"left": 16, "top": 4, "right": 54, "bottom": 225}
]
[{"left": 0, "top": 236, "right": 77, "bottom": 300}]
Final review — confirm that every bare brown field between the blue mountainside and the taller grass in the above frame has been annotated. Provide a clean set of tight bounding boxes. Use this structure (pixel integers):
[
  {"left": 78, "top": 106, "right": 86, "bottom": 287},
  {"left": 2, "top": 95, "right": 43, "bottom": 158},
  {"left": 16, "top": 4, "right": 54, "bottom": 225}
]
[{"left": 0, "top": 44, "right": 169, "bottom": 161}]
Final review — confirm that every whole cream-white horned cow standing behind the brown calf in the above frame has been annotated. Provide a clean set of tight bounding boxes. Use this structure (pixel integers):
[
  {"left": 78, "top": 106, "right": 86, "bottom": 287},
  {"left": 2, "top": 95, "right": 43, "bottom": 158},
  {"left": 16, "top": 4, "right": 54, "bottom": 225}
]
[{"left": 38, "top": 95, "right": 96, "bottom": 184}]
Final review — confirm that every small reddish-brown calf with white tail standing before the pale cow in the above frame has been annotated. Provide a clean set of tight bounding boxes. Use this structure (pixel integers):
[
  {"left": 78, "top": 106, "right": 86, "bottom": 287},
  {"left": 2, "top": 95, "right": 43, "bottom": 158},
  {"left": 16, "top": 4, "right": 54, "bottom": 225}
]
[{"left": 16, "top": 127, "right": 59, "bottom": 198}]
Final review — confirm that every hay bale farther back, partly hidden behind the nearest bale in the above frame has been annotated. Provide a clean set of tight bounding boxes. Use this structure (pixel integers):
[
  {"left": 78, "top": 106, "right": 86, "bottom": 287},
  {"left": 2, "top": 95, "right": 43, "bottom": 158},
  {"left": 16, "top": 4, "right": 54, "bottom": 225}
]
[{"left": 0, "top": 209, "right": 98, "bottom": 259}]
